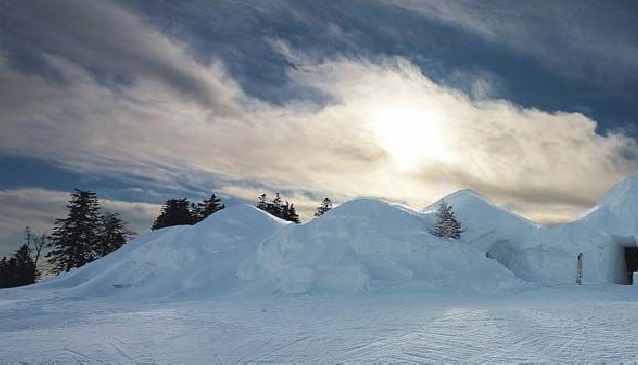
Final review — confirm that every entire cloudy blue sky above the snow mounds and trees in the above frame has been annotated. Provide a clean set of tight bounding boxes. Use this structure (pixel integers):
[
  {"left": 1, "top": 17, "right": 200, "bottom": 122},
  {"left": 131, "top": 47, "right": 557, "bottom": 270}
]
[{"left": 0, "top": 0, "right": 638, "bottom": 256}]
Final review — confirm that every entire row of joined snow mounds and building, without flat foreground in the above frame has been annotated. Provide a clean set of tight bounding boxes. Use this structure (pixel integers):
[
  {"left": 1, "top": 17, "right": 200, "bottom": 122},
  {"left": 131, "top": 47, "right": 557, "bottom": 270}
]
[{"left": 32, "top": 177, "right": 638, "bottom": 300}]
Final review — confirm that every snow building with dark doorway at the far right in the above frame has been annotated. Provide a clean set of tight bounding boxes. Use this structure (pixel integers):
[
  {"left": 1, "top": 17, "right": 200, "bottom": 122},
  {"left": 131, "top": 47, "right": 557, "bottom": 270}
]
[{"left": 436, "top": 176, "right": 638, "bottom": 284}]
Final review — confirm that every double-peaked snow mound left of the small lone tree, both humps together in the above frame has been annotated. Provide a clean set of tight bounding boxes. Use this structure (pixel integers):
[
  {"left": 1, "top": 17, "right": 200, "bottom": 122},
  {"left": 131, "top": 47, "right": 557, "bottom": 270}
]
[{"left": 36, "top": 200, "right": 530, "bottom": 300}]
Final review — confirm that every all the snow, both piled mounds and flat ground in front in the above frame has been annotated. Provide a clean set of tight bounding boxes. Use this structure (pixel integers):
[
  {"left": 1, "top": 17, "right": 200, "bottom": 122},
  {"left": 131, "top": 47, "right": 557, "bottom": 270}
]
[{"left": 0, "top": 178, "right": 638, "bottom": 363}]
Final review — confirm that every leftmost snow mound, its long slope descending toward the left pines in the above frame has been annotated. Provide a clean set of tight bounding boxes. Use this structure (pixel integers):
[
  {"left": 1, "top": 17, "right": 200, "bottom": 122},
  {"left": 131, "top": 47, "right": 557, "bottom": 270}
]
[{"left": 40, "top": 205, "right": 286, "bottom": 299}]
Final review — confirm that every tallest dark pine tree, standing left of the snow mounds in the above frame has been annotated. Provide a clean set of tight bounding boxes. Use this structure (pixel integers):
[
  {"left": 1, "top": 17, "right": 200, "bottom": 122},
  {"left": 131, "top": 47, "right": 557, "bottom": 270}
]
[{"left": 46, "top": 189, "right": 99, "bottom": 274}]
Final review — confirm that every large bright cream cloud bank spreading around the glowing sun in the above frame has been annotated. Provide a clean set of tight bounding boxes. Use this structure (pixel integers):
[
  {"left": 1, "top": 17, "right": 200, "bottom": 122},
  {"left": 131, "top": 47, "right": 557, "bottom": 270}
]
[{"left": 0, "top": 2, "right": 638, "bottom": 230}]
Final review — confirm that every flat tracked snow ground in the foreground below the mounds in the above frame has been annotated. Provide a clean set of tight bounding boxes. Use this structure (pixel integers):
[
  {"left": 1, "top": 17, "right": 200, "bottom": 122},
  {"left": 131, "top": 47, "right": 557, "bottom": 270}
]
[{"left": 0, "top": 286, "right": 638, "bottom": 363}]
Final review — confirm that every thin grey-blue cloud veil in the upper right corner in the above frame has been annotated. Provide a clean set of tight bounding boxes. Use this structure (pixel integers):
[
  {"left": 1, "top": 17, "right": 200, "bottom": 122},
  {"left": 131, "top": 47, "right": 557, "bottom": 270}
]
[{"left": 385, "top": 0, "right": 638, "bottom": 83}]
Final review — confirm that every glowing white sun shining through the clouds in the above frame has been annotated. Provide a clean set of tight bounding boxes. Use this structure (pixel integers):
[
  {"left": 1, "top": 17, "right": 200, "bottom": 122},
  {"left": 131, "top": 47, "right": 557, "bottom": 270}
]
[{"left": 371, "top": 105, "right": 444, "bottom": 171}]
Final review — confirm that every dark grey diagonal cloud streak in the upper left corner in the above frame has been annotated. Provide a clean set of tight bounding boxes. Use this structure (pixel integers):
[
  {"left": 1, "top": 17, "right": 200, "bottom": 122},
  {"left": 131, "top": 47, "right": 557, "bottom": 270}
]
[{"left": 5, "top": 0, "right": 238, "bottom": 115}]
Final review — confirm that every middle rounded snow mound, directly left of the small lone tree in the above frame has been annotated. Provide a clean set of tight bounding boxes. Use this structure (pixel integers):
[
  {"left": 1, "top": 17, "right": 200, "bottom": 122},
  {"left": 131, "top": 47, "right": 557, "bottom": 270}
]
[{"left": 238, "top": 199, "right": 526, "bottom": 293}]
